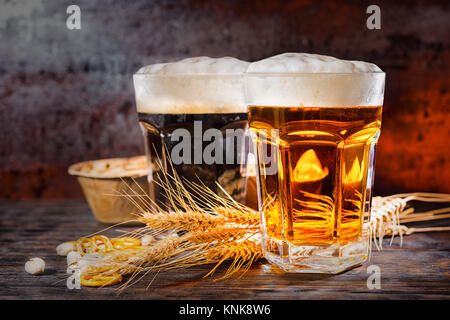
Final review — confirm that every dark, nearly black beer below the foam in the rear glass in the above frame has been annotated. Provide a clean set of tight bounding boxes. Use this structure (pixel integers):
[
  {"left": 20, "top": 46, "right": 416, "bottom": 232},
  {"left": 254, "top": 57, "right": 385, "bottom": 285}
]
[{"left": 138, "top": 113, "right": 247, "bottom": 208}]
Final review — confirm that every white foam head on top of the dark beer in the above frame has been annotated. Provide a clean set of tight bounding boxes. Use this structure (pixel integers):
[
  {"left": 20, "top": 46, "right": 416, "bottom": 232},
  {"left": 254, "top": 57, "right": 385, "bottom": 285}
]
[{"left": 134, "top": 57, "right": 249, "bottom": 114}]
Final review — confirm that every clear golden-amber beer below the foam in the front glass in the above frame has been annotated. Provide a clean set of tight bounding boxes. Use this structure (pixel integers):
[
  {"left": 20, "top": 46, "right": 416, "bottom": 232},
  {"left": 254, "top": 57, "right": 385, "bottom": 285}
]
[{"left": 249, "top": 106, "right": 382, "bottom": 245}]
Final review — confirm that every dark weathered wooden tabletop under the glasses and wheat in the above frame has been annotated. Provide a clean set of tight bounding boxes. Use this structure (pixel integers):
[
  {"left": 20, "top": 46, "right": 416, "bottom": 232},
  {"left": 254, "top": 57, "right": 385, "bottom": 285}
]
[{"left": 0, "top": 201, "right": 450, "bottom": 300}]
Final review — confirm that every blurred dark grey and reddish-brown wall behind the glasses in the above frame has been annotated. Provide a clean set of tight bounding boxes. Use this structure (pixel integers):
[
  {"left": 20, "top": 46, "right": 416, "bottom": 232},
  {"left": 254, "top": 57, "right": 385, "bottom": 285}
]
[{"left": 0, "top": 0, "right": 450, "bottom": 199}]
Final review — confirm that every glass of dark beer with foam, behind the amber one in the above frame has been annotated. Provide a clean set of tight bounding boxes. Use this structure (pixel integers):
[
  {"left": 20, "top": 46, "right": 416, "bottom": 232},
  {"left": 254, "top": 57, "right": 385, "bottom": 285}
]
[{"left": 133, "top": 57, "right": 248, "bottom": 208}]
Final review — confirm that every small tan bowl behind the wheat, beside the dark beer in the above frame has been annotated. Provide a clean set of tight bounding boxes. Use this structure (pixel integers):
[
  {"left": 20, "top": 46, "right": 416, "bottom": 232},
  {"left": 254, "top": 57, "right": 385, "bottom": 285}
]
[{"left": 68, "top": 156, "right": 148, "bottom": 224}]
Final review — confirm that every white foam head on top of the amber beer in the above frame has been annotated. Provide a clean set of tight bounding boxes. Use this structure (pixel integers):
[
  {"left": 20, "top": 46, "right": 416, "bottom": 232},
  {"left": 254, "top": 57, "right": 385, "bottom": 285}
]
[{"left": 246, "top": 53, "right": 384, "bottom": 107}]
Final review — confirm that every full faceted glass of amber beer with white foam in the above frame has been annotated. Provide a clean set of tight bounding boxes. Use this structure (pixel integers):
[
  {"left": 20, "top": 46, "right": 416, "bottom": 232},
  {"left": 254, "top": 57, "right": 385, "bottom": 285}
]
[{"left": 245, "top": 56, "right": 385, "bottom": 273}]
